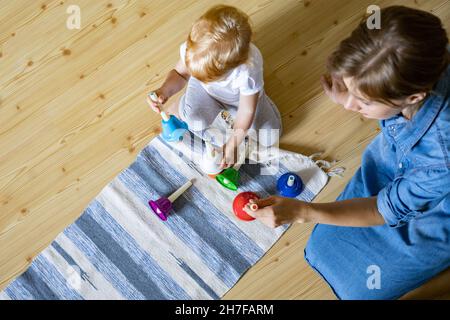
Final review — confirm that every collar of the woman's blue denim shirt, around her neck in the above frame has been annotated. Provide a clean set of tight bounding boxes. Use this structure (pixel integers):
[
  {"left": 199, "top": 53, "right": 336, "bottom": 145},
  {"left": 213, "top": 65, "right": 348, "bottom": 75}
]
[{"left": 380, "top": 67, "right": 450, "bottom": 154}]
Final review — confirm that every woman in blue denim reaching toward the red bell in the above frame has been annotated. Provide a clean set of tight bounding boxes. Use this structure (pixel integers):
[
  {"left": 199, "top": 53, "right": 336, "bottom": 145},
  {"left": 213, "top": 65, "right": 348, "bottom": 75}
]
[{"left": 247, "top": 6, "right": 450, "bottom": 299}]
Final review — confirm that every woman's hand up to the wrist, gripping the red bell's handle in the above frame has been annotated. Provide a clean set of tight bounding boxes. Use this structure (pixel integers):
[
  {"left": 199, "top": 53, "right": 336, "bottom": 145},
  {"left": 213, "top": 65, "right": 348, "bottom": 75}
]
[{"left": 244, "top": 196, "right": 309, "bottom": 228}]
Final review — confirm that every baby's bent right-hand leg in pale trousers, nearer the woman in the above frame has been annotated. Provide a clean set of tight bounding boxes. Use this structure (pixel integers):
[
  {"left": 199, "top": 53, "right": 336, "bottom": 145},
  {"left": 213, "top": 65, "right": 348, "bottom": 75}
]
[{"left": 249, "top": 94, "right": 282, "bottom": 147}]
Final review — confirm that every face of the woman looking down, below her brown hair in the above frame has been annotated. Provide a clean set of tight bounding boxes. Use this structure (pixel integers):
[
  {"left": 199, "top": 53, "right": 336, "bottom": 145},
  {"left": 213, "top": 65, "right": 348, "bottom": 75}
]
[{"left": 342, "top": 78, "right": 405, "bottom": 120}]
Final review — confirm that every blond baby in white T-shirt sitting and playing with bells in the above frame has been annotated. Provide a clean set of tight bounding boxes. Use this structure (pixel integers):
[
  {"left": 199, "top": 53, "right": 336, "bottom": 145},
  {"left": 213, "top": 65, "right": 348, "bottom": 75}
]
[{"left": 147, "top": 5, "right": 281, "bottom": 168}]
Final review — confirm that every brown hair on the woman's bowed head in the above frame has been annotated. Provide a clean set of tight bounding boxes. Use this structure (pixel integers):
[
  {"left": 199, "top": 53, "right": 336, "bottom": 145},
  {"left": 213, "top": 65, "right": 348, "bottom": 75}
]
[{"left": 328, "top": 6, "right": 449, "bottom": 104}]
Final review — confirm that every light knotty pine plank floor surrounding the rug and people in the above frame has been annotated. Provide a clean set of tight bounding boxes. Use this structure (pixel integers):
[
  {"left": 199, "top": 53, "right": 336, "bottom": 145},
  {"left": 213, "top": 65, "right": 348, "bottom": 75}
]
[{"left": 0, "top": 0, "right": 450, "bottom": 299}]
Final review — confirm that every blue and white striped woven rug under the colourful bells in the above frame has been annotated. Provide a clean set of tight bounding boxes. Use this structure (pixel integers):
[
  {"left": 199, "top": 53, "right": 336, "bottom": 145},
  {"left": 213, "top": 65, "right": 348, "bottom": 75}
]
[{"left": 0, "top": 133, "right": 328, "bottom": 299}]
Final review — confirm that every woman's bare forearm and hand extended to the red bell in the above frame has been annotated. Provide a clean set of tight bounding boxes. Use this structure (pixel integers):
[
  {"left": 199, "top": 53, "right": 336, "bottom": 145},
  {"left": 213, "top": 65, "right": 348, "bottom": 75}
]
[{"left": 244, "top": 196, "right": 385, "bottom": 228}]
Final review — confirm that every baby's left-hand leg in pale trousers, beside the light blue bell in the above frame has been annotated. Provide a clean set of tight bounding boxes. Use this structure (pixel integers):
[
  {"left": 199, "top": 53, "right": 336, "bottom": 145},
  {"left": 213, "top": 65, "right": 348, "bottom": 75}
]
[{"left": 179, "top": 77, "right": 224, "bottom": 142}]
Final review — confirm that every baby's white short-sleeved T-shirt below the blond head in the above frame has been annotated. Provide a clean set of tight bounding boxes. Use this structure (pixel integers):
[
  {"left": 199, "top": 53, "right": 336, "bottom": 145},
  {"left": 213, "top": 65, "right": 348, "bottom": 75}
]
[{"left": 180, "top": 42, "right": 264, "bottom": 106}]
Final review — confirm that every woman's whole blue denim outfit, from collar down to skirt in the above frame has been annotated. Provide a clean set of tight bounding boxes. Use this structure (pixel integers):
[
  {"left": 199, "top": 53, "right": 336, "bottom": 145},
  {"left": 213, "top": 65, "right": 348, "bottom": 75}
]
[{"left": 305, "top": 63, "right": 450, "bottom": 299}]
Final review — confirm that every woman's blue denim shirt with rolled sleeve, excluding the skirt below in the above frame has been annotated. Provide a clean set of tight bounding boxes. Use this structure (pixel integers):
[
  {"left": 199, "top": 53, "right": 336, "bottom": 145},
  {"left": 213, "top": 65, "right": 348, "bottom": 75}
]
[{"left": 340, "top": 63, "right": 450, "bottom": 227}]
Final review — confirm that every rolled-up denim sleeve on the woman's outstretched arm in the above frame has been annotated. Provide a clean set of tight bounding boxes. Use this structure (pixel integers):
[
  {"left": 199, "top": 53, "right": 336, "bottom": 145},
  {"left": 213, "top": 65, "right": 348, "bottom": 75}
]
[{"left": 377, "top": 167, "right": 450, "bottom": 227}]
